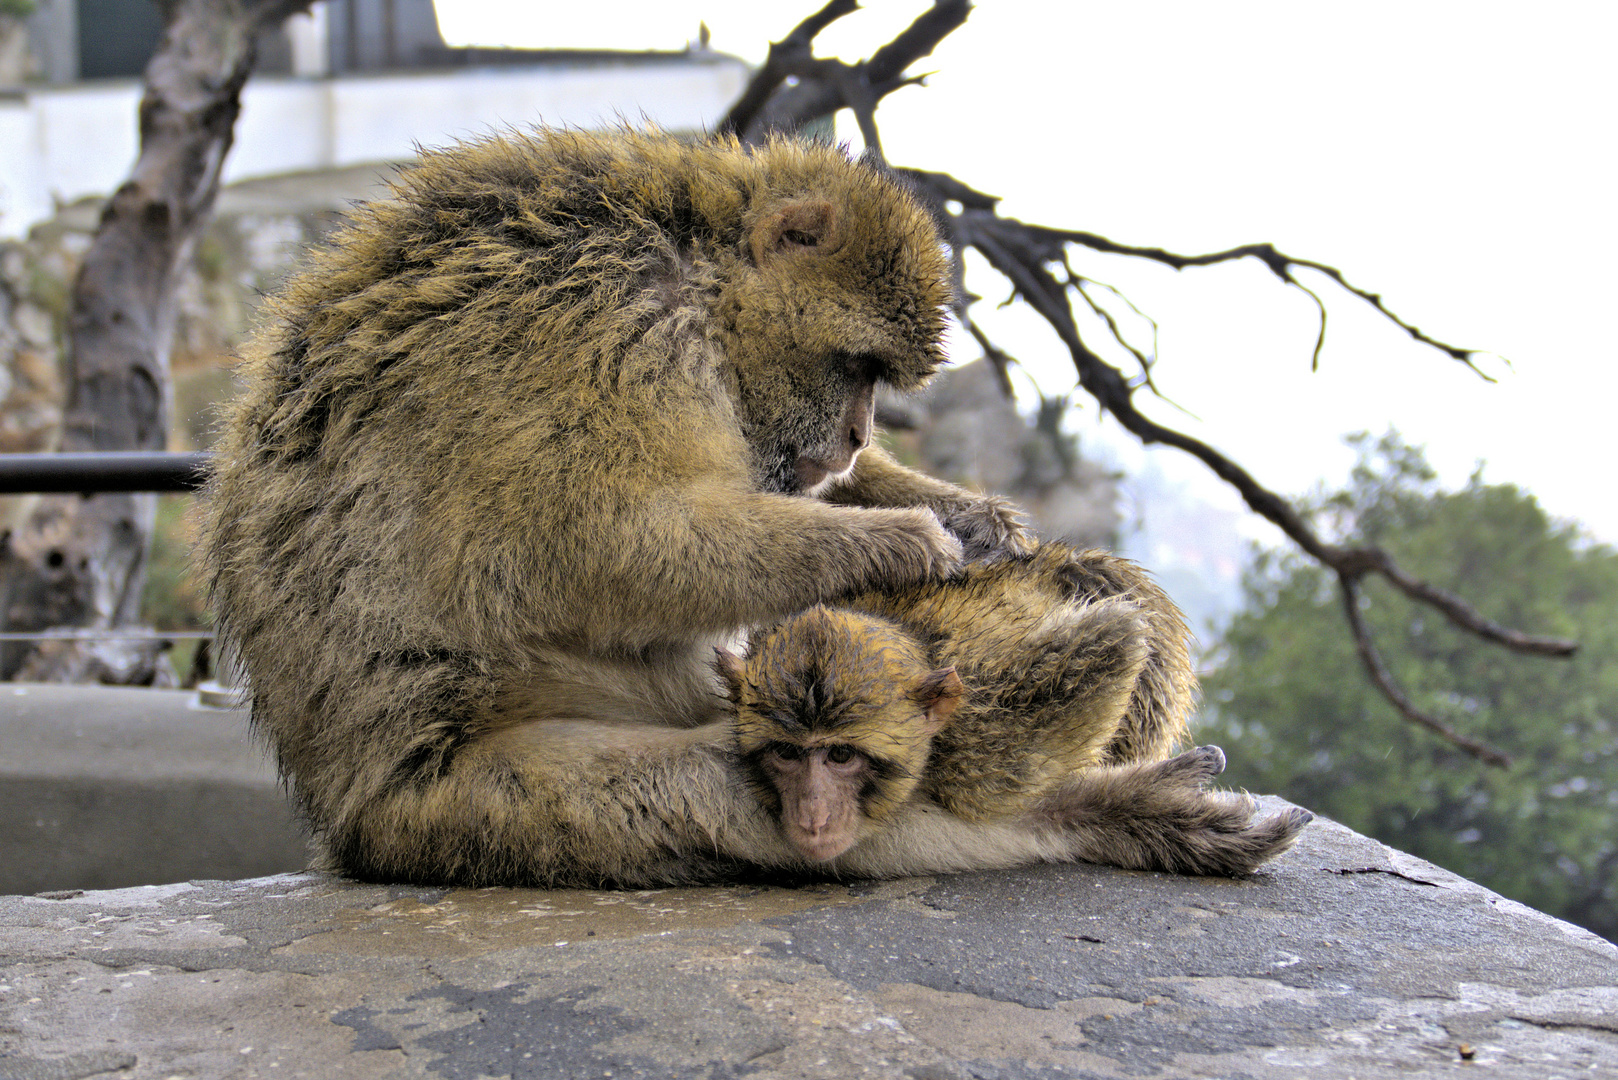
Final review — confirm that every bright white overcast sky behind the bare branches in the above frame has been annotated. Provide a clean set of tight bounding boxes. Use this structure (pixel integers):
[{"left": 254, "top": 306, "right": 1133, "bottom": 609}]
[{"left": 440, "top": 0, "right": 1618, "bottom": 541}]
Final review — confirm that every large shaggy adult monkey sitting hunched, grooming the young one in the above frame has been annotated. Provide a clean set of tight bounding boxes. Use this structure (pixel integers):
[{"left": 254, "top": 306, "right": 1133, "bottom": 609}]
[{"left": 201, "top": 133, "right": 1152, "bottom": 884}]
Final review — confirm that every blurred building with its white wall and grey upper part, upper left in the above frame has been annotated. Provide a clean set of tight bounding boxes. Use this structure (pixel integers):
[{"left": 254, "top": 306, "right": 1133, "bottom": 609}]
[{"left": 0, "top": 0, "right": 748, "bottom": 236}]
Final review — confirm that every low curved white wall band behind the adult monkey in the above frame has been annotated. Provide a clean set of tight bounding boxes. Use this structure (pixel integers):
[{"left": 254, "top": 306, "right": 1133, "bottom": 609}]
[{"left": 0, "top": 58, "right": 748, "bottom": 236}]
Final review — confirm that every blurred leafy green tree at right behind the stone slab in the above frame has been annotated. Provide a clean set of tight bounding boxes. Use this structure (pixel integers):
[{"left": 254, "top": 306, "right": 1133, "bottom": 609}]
[{"left": 1199, "top": 434, "right": 1618, "bottom": 939}]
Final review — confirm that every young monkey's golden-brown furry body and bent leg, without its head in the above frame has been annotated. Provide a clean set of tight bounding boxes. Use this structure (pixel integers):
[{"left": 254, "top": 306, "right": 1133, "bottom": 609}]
[{"left": 849, "top": 542, "right": 1196, "bottom": 818}]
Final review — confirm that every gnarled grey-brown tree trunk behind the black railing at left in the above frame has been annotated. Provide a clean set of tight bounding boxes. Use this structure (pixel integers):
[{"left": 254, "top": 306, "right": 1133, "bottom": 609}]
[{"left": 0, "top": 0, "right": 311, "bottom": 683}]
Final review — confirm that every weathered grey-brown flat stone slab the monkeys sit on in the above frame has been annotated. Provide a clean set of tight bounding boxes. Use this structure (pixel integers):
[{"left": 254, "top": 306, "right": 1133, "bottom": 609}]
[{"left": 0, "top": 800, "right": 1618, "bottom": 1080}]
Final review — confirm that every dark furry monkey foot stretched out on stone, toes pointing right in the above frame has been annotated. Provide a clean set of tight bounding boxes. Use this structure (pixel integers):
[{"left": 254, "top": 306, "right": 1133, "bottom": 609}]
[{"left": 1044, "top": 746, "right": 1314, "bottom": 878}]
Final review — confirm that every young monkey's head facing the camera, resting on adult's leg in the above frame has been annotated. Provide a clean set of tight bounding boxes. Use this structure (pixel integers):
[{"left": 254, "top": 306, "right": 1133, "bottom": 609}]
[{"left": 717, "top": 607, "right": 966, "bottom": 863}]
